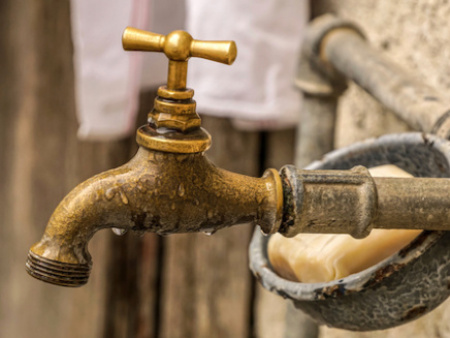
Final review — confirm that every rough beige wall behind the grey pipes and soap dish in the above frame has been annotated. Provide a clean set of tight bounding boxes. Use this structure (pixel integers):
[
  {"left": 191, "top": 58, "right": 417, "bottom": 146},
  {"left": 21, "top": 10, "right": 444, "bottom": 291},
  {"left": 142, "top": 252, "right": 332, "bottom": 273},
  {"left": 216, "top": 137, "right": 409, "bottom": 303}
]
[{"left": 313, "top": 0, "right": 450, "bottom": 338}]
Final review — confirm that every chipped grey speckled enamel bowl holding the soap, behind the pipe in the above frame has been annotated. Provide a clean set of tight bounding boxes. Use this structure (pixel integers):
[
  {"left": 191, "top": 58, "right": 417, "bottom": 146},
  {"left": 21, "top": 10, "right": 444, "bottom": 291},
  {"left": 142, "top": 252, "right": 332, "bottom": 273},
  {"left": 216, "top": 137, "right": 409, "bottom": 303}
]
[{"left": 250, "top": 133, "right": 450, "bottom": 331}]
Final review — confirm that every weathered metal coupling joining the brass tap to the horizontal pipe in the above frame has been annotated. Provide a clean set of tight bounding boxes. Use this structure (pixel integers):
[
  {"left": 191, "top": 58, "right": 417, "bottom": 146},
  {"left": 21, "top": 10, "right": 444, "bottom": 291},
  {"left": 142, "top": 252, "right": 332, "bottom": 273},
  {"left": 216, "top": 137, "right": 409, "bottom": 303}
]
[{"left": 279, "top": 165, "right": 377, "bottom": 238}]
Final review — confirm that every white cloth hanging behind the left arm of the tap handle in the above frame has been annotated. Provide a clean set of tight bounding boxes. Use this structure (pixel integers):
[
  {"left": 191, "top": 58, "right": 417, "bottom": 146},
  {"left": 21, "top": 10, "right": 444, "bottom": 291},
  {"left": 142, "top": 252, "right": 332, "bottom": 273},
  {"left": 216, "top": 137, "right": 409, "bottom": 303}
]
[{"left": 71, "top": 0, "right": 149, "bottom": 140}]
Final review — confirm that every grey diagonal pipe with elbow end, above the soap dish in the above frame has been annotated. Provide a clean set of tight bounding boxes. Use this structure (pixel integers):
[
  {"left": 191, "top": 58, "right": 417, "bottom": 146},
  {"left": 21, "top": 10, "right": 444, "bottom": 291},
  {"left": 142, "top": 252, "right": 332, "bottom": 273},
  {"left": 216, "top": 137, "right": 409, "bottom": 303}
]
[{"left": 308, "top": 15, "right": 450, "bottom": 139}]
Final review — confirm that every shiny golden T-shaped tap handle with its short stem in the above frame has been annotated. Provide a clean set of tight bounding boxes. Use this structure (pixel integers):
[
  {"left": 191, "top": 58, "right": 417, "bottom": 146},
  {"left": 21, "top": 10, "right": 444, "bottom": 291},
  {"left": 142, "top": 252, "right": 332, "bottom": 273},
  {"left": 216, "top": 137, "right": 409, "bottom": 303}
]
[{"left": 122, "top": 27, "right": 237, "bottom": 91}]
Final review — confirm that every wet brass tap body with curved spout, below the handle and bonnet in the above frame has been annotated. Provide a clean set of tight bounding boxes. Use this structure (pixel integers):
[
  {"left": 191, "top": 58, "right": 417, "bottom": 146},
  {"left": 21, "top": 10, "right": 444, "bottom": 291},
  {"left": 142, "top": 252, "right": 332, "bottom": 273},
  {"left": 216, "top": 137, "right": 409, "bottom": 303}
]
[{"left": 26, "top": 147, "right": 283, "bottom": 286}]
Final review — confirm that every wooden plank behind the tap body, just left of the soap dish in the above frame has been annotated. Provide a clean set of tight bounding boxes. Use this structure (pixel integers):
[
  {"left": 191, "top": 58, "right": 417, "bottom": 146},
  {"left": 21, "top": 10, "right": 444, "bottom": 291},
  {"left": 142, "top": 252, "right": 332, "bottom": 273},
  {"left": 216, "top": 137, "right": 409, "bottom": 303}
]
[{"left": 160, "top": 117, "right": 259, "bottom": 337}]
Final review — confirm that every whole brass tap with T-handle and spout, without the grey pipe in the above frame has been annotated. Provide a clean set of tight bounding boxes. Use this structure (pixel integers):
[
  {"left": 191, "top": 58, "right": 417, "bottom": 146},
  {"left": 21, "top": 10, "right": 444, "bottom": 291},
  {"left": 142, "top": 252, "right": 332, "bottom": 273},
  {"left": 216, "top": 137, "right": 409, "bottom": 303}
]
[{"left": 26, "top": 28, "right": 283, "bottom": 286}]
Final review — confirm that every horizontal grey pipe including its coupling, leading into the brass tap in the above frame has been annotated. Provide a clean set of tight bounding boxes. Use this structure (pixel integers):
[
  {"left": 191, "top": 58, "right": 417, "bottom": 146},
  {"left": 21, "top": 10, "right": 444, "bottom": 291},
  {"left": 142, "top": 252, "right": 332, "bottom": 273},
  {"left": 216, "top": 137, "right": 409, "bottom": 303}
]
[{"left": 279, "top": 166, "right": 450, "bottom": 238}]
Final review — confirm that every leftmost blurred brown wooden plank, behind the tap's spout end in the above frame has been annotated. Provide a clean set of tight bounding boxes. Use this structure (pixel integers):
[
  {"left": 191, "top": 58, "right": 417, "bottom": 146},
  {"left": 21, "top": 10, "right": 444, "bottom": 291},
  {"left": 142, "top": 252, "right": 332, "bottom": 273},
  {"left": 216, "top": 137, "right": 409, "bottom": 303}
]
[{"left": 0, "top": 0, "right": 153, "bottom": 337}]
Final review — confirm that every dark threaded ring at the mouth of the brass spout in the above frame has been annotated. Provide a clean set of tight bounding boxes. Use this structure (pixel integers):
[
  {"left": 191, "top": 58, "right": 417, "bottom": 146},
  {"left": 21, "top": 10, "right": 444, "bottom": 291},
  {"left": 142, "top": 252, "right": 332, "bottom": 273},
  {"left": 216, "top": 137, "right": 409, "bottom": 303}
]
[{"left": 25, "top": 251, "right": 91, "bottom": 287}]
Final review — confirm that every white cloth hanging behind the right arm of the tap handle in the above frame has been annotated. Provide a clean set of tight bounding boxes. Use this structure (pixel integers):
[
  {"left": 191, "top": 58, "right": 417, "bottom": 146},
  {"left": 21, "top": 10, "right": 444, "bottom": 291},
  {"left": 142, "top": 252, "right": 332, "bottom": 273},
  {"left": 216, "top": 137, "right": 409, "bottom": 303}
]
[{"left": 186, "top": 0, "right": 309, "bottom": 129}]
